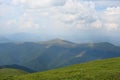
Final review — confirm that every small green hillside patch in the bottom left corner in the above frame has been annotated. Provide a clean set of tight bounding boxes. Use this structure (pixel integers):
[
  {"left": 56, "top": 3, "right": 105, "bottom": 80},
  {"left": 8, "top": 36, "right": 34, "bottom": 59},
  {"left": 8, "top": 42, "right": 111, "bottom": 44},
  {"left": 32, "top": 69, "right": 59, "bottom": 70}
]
[{"left": 0, "top": 68, "right": 27, "bottom": 80}]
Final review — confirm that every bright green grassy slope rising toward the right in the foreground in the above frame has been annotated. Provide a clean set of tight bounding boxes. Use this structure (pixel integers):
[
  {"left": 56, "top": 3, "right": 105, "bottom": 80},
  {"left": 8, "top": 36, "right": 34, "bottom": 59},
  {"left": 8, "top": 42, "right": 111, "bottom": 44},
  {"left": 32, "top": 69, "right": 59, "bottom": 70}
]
[{"left": 11, "top": 58, "right": 120, "bottom": 80}]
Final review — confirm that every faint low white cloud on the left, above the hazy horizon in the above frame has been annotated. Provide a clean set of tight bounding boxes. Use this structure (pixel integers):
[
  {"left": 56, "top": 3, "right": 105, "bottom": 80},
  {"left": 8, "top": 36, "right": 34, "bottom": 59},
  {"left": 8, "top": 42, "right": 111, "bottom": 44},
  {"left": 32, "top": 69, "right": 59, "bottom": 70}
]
[{"left": 4, "top": 15, "right": 40, "bottom": 32}]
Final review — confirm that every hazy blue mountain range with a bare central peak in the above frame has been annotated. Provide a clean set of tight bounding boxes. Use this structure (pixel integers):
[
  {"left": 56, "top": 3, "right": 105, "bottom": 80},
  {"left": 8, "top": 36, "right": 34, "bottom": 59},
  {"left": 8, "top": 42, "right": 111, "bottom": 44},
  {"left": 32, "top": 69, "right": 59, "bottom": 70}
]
[{"left": 0, "top": 39, "right": 120, "bottom": 71}]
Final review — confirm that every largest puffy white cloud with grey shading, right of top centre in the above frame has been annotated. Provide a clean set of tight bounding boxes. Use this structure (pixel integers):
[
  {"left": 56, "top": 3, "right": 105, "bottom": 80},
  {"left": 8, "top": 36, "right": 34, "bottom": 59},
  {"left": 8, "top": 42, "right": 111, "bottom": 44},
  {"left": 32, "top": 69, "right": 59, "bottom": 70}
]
[{"left": 47, "top": 0, "right": 96, "bottom": 28}]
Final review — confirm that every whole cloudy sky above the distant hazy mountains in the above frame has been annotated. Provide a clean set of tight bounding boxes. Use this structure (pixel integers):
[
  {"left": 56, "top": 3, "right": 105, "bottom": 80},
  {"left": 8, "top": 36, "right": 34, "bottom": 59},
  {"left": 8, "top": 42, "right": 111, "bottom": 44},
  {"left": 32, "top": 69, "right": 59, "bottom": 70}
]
[{"left": 0, "top": 0, "right": 120, "bottom": 43}]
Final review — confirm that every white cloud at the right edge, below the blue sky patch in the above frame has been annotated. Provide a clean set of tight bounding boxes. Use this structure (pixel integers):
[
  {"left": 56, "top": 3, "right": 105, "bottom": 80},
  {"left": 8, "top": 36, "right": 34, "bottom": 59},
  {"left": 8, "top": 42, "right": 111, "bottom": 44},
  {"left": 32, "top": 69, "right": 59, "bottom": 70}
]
[{"left": 102, "top": 7, "right": 120, "bottom": 31}]
